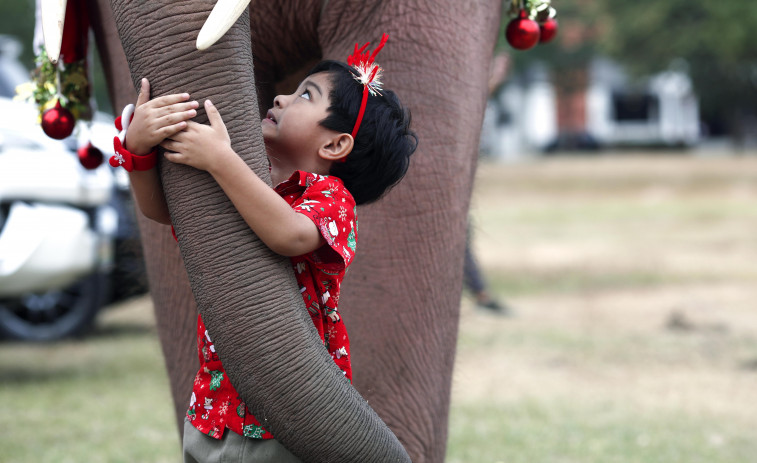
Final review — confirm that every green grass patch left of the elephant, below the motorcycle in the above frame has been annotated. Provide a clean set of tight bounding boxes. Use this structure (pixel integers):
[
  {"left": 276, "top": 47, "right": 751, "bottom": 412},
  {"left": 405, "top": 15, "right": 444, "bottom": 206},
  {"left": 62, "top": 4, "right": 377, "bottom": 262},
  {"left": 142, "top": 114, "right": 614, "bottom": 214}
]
[{"left": 0, "top": 306, "right": 181, "bottom": 463}]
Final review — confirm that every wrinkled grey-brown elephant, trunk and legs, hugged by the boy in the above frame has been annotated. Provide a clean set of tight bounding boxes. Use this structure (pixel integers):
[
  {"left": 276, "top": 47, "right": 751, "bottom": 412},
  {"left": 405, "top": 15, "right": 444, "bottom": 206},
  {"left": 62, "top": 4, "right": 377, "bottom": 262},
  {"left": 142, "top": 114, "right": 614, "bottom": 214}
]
[{"left": 89, "top": 0, "right": 500, "bottom": 462}]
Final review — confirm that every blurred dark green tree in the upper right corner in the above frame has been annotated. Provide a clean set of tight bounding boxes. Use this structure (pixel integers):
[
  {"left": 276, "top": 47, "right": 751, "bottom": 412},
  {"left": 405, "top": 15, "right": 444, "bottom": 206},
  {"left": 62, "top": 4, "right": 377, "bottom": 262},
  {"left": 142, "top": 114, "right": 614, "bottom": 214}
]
[{"left": 600, "top": 0, "right": 757, "bottom": 136}]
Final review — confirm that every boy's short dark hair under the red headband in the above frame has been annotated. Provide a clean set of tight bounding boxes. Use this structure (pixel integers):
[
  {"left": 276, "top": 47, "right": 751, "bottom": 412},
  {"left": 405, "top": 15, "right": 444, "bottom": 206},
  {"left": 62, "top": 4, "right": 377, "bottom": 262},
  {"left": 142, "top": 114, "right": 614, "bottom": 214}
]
[{"left": 308, "top": 61, "right": 418, "bottom": 204}]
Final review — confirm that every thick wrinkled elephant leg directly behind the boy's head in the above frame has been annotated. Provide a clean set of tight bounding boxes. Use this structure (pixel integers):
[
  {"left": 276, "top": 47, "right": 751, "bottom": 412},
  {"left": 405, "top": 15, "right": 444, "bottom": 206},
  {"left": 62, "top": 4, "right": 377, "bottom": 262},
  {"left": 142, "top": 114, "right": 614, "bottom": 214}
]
[{"left": 319, "top": 0, "right": 501, "bottom": 463}]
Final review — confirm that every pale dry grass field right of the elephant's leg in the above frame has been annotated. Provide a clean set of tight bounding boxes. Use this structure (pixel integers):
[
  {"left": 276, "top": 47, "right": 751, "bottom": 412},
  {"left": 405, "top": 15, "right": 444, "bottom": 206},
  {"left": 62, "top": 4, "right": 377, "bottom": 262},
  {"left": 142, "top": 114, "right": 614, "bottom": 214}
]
[{"left": 448, "top": 156, "right": 757, "bottom": 463}]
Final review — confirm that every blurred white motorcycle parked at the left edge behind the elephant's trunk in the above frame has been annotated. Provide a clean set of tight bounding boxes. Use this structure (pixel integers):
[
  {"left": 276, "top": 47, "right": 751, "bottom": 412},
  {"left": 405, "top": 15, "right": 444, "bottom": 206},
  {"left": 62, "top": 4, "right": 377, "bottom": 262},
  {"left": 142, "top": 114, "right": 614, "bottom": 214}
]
[{"left": 0, "top": 98, "right": 127, "bottom": 341}]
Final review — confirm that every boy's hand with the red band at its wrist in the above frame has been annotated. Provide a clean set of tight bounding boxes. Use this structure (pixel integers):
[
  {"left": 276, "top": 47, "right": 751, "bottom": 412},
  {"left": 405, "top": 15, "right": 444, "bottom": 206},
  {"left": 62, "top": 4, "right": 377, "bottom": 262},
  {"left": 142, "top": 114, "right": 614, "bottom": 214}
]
[{"left": 125, "top": 79, "right": 199, "bottom": 155}]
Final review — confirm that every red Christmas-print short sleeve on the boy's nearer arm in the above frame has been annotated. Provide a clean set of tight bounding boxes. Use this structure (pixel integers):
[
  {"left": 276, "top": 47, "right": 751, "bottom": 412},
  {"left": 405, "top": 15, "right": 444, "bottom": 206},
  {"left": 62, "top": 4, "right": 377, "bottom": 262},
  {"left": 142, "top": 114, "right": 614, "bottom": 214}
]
[{"left": 292, "top": 176, "right": 357, "bottom": 272}]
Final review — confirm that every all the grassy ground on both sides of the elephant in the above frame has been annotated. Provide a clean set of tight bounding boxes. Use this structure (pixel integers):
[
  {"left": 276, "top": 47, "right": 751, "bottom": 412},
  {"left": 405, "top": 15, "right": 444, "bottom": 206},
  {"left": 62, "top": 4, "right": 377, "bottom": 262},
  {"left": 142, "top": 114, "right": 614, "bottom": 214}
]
[{"left": 0, "top": 153, "right": 757, "bottom": 463}]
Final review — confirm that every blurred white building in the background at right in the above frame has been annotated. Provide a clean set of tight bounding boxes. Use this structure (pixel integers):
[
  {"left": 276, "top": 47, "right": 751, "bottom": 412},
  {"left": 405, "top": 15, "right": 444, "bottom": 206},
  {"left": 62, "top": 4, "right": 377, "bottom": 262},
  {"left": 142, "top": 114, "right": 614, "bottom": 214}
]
[{"left": 481, "top": 58, "right": 700, "bottom": 160}]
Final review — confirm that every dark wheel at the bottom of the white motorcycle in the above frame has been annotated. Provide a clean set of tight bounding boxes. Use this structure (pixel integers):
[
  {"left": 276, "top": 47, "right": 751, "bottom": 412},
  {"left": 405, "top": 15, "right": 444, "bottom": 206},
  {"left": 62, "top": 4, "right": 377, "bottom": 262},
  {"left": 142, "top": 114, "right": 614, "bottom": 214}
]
[{"left": 0, "top": 273, "right": 107, "bottom": 341}]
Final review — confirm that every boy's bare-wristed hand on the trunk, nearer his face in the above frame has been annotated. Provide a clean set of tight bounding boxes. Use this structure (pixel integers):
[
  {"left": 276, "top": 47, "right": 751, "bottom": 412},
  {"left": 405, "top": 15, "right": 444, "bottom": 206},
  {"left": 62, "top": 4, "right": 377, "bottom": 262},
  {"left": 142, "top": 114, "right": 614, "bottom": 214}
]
[{"left": 160, "top": 100, "right": 230, "bottom": 171}]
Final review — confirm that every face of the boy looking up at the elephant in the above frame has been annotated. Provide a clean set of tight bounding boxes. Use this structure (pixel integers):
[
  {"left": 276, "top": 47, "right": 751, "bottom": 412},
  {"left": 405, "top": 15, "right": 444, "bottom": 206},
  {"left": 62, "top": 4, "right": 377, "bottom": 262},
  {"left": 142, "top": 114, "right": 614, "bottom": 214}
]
[{"left": 261, "top": 72, "right": 334, "bottom": 170}]
